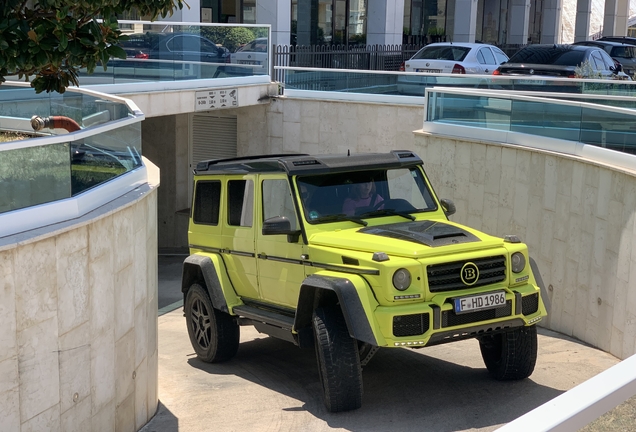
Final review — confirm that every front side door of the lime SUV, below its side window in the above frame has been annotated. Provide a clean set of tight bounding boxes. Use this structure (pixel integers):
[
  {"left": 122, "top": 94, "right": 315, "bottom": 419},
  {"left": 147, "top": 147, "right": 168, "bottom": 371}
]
[{"left": 256, "top": 174, "right": 306, "bottom": 308}]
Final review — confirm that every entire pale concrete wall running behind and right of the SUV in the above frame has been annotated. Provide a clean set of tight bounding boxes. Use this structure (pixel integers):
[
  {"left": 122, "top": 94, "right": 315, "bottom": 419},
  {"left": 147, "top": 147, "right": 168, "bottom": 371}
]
[{"left": 238, "top": 98, "right": 636, "bottom": 359}]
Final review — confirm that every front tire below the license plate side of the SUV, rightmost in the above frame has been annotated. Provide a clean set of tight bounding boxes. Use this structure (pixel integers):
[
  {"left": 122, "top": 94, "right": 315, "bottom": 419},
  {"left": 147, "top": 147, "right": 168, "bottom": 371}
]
[{"left": 479, "top": 326, "right": 537, "bottom": 381}]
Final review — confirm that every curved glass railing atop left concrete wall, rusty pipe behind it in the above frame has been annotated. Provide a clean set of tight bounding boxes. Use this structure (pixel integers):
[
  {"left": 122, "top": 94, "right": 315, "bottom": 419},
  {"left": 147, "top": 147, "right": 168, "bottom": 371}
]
[{"left": 0, "top": 83, "right": 143, "bottom": 213}]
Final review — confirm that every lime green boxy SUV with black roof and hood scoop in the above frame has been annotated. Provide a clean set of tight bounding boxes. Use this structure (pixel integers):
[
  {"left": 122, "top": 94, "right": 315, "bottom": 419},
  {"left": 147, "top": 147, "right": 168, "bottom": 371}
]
[{"left": 182, "top": 151, "right": 546, "bottom": 412}]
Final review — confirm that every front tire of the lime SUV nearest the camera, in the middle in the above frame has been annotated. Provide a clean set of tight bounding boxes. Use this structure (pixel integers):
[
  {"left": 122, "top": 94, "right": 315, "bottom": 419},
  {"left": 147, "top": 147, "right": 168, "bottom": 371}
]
[{"left": 313, "top": 306, "right": 362, "bottom": 412}]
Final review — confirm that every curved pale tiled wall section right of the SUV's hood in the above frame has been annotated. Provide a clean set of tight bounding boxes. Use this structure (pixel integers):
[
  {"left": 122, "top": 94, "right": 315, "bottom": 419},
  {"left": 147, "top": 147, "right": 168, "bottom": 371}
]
[{"left": 413, "top": 132, "right": 636, "bottom": 359}]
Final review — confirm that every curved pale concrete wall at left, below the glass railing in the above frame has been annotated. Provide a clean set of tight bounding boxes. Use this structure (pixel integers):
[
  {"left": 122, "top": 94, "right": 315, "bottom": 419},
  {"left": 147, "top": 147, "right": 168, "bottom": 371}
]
[{"left": 0, "top": 181, "right": 158, "bottom": 432}]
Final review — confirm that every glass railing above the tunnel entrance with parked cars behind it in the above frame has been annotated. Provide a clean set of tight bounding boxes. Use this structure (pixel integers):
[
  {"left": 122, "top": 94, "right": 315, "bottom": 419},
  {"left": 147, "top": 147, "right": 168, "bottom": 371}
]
[{"left": 80, "top": 21, "right": 271, "bottom": 86}]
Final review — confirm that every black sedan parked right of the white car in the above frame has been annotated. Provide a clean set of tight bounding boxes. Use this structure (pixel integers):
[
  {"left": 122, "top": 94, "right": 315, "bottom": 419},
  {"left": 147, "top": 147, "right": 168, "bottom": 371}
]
[{"left": 493, "top": 44, "right": 629, "bottom": 79}]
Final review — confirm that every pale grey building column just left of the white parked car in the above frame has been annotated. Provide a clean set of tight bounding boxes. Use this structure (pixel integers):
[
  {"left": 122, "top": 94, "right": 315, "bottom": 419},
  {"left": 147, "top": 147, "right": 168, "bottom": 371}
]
[{"left": 366, "top": 0, "right": 404, "bottom": 45}]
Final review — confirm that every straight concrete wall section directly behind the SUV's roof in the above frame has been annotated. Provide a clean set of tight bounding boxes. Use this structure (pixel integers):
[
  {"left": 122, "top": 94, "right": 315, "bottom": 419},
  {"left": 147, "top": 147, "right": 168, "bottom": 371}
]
[{"left": 237, "top": 98, "right": 424, "bottom": 155}]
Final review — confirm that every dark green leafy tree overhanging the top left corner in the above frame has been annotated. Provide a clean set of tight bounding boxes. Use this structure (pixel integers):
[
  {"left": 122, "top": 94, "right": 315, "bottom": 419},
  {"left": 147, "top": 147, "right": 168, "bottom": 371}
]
[{"left": 0, "top": 0, "right": 187, "bottom": 93}]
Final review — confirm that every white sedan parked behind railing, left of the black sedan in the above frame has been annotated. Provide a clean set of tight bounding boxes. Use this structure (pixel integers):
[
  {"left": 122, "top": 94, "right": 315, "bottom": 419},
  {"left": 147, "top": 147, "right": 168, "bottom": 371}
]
[{"left": 404, "top": 42, "right": 508, "bottom": 74}]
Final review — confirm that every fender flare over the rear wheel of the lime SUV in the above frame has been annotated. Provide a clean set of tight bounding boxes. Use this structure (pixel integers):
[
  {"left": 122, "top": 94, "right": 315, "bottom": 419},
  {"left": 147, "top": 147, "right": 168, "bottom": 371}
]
[{"left": 181, "top": 255, "right": 230, "bottom": 313}]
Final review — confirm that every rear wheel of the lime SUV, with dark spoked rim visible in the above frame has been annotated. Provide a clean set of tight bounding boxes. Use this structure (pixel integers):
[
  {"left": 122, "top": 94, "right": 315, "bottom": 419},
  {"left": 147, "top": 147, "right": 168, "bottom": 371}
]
[{"left": 184, "top": 284, "right": 240, "bottom": 363}]
